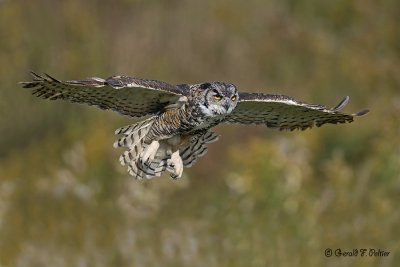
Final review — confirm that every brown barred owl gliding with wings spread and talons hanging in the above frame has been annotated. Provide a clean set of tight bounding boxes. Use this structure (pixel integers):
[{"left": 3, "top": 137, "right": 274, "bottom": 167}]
[{"left": 21, "top": 72, "right": 368, "bottom": 179}]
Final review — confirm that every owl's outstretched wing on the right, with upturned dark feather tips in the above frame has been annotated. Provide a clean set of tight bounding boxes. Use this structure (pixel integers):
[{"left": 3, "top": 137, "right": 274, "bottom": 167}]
[{"left": 226, "top": 93, "right": 368, "bottom": 130}]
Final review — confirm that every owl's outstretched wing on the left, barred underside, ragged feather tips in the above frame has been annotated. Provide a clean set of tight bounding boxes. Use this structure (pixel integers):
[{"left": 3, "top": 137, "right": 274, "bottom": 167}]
[{"left": 21, "top": 72, "right": 186, "bottom": 117}]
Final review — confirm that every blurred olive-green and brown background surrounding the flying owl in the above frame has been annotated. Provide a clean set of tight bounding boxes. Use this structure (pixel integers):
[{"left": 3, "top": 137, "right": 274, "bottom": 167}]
[{"left": 0, "top": 0, "right": 400, "bottom": 267}]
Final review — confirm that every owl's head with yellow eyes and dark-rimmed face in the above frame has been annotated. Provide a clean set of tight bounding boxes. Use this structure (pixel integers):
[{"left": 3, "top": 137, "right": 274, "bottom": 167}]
[{"left": 194, "top": 82, "right": 239, "bottom": 116}]
